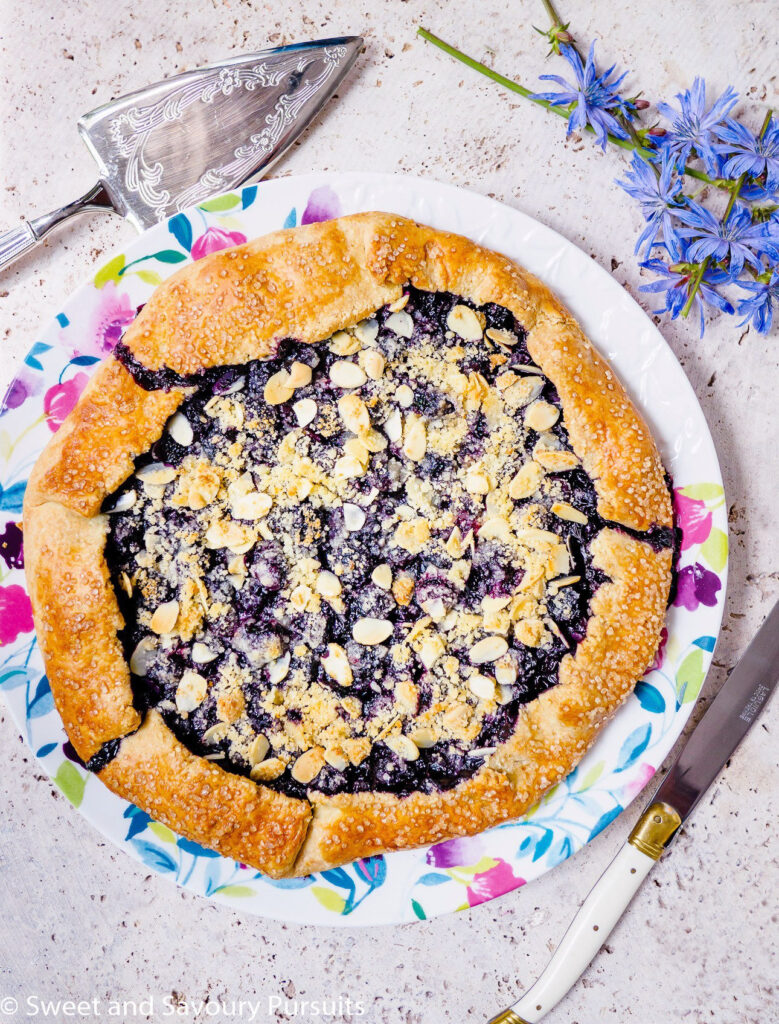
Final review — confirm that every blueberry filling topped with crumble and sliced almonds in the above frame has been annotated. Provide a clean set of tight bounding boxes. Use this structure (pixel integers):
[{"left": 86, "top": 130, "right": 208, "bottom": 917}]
[{"left": 103, "top": 288, "right": 673, "bottom": 797}]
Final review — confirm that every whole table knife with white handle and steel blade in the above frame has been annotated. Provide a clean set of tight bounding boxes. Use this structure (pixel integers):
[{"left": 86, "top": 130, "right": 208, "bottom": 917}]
[{"left": 489, "top": 602, "right": 779, "bottom": 1024}]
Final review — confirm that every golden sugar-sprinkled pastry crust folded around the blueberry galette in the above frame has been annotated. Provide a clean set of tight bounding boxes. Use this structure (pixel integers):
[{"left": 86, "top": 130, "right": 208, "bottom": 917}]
[{"left": 25, "top": 213, "right": 673, "bottom": 876}]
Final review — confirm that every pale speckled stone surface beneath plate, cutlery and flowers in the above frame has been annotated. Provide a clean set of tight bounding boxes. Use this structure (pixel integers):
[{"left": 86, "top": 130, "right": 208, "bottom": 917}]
[{"left": 0, "top": 0, "right": 779, "bottom": 1024}]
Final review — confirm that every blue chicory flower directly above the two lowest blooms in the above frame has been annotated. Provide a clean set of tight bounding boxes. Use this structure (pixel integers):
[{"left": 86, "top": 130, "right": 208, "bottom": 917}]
[{"left": 677, "top": 200, "right": 779, "bottom": 278}]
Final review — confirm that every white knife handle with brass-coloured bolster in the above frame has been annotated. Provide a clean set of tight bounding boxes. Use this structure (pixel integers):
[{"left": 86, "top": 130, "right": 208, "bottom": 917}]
[{"left": 489, "top": 804, "right": 681, "bottom": 1024}]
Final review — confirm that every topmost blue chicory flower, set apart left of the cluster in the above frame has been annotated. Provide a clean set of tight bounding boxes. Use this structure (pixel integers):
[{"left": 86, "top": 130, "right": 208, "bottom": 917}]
[{"left": 533, "top": 43, "right": 635, "bottom": 150}]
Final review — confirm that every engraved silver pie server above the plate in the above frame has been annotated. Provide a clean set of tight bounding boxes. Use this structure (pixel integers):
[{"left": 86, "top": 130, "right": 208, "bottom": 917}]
[{"left": 0, "top": 36, "right": 362, "bottom": 270}]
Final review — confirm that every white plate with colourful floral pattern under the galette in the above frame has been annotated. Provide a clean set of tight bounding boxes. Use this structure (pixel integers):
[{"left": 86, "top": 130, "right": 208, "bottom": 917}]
[{"left": 0, "top": 174, "right": 728, "bottom": 925}]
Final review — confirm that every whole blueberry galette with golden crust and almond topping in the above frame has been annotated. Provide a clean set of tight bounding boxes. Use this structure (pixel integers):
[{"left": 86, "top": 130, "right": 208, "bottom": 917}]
[{"left": 25, "top": 214, "right": 674, "bottom": 876}]
